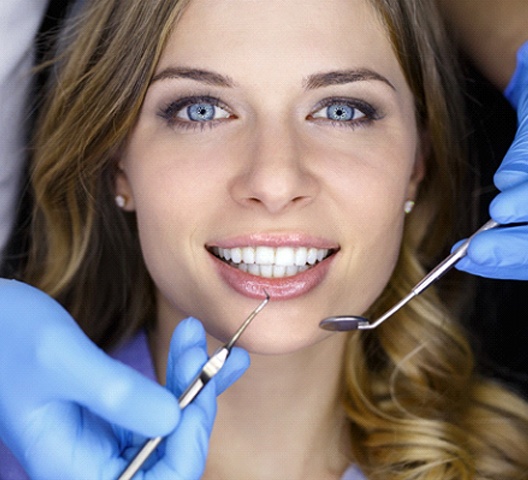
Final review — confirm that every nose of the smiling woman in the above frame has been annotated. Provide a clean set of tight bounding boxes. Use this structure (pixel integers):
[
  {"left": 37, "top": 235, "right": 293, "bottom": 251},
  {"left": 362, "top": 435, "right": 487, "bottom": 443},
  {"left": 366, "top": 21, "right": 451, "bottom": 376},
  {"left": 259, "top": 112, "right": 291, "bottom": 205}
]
[{"left": 231, "top": 125, "right": 319, "bottom": 214}]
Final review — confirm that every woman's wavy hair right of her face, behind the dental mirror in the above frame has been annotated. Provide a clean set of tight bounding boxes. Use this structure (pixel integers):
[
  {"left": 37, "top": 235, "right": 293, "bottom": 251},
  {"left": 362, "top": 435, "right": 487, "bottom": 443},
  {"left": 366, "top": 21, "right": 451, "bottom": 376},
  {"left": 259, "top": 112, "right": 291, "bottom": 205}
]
[{"left": 343, "top": 0, "right": 528, "bottom": 480}]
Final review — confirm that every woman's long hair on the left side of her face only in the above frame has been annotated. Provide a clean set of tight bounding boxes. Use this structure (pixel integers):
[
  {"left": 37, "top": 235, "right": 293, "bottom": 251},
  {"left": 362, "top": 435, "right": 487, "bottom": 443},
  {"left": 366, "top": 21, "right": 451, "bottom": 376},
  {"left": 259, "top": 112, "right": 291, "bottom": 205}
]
[{"left": 25, "top": 0, "right": 187, "bottom": 348}]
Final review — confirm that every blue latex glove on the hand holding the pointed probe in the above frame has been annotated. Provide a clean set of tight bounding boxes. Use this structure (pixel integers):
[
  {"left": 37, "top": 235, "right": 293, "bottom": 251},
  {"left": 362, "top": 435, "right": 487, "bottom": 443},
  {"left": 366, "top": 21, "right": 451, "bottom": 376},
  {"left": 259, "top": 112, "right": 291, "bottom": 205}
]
[{"left": 0, "top": 279, "right": 249, "bottom": 480}]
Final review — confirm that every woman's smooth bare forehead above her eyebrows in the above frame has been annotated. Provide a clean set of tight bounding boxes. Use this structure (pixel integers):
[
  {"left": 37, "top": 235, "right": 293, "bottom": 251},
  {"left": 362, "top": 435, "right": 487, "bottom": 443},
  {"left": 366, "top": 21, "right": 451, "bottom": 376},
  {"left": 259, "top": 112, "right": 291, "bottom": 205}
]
[{"left": 158, "top": 0, "right": 402, "bottom": 87}]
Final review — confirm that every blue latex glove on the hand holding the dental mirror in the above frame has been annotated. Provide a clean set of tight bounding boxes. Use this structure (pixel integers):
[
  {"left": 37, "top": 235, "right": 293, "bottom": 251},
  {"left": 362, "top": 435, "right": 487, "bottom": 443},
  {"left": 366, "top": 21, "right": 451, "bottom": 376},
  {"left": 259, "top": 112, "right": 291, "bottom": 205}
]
[{"left": 457, "top": 42, "right": 528, "bottom": 280}]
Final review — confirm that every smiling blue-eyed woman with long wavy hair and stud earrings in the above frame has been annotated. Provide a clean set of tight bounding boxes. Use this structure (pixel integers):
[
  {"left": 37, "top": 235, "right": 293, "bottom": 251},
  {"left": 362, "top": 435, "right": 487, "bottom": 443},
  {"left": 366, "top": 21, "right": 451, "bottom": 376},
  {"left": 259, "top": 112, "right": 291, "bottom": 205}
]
[{"left": 3, "top": 0, "right": 528, "bottom": 479}]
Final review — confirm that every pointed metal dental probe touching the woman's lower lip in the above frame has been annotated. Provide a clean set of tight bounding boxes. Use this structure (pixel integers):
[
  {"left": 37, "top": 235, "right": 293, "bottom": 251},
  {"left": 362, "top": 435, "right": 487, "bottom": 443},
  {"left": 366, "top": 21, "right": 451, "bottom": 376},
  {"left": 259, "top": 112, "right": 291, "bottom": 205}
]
[{"left": 118, "top": 292, "right": 270, "bottom": 480}]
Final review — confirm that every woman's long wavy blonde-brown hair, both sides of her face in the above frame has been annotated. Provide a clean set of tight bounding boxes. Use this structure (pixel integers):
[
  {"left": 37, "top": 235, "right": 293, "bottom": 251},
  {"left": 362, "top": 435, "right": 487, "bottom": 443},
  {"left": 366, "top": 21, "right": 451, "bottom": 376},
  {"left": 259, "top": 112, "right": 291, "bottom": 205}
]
[{"left": 23, "top": 0, "right": 528, "bottom": 480}]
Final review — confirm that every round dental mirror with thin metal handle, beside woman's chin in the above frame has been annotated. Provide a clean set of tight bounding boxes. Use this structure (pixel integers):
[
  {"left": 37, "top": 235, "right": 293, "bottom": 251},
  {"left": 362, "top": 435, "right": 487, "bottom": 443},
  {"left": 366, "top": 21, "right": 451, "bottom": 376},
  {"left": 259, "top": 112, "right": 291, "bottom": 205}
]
[{"left": 319, "top": 220, "right": 499, "bottom": 332}]
